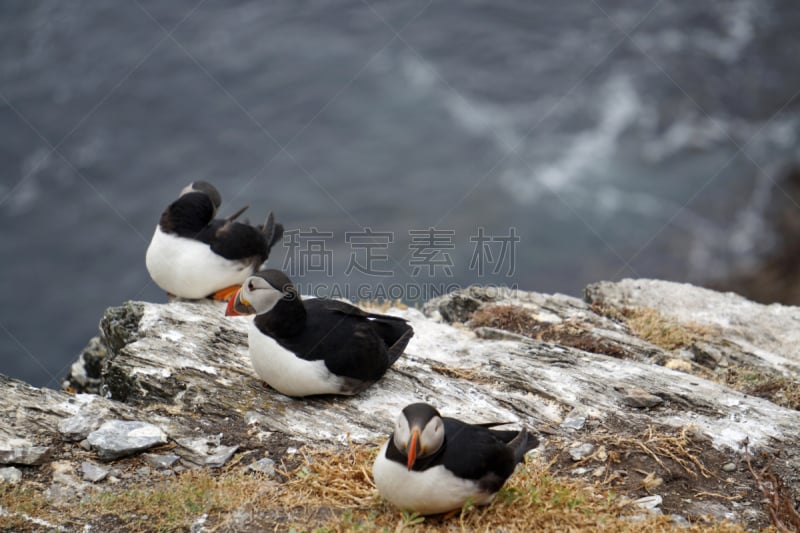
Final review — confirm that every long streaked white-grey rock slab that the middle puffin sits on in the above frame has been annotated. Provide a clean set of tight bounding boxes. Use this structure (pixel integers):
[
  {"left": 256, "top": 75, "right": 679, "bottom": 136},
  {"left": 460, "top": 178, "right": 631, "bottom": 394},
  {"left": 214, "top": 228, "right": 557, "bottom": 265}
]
[{"left": 86, "top": 284, "right": 800, "bottom": 454}]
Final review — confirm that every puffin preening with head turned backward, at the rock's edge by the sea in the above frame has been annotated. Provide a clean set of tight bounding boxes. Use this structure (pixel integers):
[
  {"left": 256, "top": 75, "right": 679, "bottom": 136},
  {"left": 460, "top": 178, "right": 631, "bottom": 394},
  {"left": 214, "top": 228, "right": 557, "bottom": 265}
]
[{"left": 145, "top": 181, "right": 283, "bottom": 300}]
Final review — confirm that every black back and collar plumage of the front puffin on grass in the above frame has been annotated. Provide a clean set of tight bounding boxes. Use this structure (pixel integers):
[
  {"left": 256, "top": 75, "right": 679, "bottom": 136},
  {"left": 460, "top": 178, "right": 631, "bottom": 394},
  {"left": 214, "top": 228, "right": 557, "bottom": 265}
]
[{"left": 386, "top": 417, "right": 539, "bottom": 492}]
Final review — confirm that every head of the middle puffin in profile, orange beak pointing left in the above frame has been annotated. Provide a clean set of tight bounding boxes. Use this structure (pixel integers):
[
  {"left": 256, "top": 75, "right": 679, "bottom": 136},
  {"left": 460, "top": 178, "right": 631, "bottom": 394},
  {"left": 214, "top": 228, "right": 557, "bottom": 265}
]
[{"left": 225, "top": 269, "right": 298, "bottom": 316}]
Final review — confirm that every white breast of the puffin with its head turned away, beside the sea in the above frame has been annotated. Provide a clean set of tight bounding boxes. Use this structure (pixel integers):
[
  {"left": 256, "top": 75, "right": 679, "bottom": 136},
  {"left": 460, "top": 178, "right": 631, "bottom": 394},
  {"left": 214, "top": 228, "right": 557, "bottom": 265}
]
[{"left": 145, "top": 226, "right": 253, "bottom": 299}]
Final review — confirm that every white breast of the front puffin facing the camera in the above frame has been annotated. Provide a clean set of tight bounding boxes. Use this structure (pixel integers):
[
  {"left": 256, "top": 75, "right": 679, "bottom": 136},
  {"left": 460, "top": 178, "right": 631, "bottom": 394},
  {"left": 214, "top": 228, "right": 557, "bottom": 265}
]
[{"left": 372, "top": 441, "right": 494, "bottom": 514}]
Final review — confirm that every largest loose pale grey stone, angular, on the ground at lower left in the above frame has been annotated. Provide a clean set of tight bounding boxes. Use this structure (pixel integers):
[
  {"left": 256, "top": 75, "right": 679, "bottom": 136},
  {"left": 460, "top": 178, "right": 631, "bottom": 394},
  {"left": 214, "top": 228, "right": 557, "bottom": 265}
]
[{"left": 87, "top": 420, "right": 167, "bottom": 461}]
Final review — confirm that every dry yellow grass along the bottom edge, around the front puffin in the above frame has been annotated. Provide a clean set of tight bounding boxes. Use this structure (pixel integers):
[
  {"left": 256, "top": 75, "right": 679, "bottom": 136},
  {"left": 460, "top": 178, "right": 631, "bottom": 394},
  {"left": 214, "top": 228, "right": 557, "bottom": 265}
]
[{"left": 0, "top": 445, "right": 744, "bottom": 533}]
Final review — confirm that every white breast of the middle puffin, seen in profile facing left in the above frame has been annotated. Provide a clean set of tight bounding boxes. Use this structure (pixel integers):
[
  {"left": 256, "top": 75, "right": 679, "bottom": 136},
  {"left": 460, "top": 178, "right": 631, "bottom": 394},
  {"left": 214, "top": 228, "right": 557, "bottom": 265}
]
[{"left": 248, "top": 322, "right": 344, "bottom": 396}]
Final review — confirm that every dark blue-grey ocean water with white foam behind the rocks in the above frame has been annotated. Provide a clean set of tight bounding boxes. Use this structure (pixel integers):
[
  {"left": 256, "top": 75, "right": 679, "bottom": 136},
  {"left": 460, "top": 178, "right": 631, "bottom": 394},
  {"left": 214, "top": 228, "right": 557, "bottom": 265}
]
[{"left": 0, "top": 0, "right": 800, "bottom": 386}]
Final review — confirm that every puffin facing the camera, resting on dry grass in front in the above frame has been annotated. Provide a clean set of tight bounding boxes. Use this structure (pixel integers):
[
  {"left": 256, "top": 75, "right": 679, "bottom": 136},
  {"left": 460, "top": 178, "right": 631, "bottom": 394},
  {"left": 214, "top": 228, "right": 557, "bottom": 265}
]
[{"left": 372, "top": 403, "right": 539, "bottom": 515}]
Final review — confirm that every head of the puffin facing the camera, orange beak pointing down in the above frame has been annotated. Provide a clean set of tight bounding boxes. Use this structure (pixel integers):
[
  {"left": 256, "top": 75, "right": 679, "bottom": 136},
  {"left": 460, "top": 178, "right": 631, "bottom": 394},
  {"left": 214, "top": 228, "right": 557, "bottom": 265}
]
[{"left": 393, "top": 403, "right": 444, "bottom": 470}]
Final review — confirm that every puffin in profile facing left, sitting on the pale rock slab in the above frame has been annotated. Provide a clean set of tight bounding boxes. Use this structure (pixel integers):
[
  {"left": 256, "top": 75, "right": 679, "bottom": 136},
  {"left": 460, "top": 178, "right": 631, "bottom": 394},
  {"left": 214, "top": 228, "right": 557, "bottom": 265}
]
[{"left": 225, "top": 269, "right": 414, "bottom": 397}]
